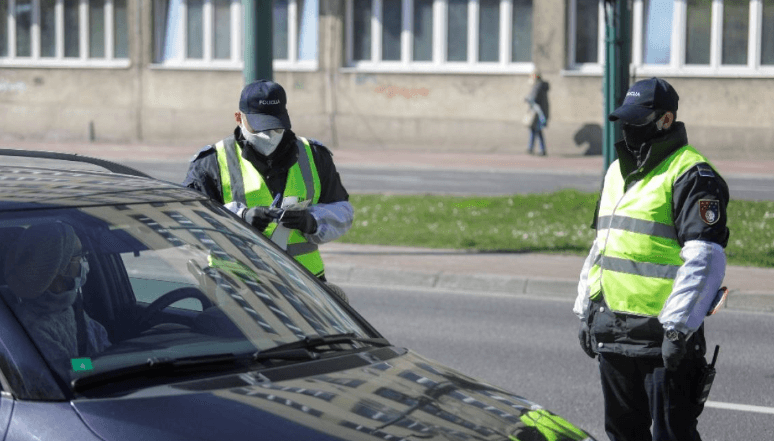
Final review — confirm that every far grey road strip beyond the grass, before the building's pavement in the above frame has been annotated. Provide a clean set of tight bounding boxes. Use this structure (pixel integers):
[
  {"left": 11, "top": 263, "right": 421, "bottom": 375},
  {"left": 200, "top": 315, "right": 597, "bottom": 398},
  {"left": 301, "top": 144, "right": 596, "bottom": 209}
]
[{"left": 129, "top": 161, "right": 774, "bottom": 201}]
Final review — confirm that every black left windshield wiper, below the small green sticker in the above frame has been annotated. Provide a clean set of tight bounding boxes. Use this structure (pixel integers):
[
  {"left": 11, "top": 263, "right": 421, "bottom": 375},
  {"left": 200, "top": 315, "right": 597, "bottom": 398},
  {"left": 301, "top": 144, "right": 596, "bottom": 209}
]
[{"left": 70, "top": 353, "right": 250, "bottom": 392}]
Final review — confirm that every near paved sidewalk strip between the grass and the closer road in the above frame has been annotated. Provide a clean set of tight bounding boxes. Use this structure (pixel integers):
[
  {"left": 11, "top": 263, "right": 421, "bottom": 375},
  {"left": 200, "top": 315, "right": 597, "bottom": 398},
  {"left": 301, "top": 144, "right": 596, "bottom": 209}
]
[{"left": 320, "top": 242, "right": 774, "bottom": 312}]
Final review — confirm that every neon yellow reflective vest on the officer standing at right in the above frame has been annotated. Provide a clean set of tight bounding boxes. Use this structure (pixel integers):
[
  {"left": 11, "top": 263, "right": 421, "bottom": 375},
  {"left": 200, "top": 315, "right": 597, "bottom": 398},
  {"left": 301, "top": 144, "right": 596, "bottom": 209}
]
[{"left": 589, "top": 145, "right": 720, "bottom": 317}]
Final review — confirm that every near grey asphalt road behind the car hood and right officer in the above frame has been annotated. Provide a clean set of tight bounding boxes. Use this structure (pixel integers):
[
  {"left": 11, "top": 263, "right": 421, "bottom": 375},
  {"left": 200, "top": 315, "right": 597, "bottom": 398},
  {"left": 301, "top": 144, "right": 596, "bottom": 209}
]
[{"left": 342, "top": 285, "right": 774, "bottom": 441}]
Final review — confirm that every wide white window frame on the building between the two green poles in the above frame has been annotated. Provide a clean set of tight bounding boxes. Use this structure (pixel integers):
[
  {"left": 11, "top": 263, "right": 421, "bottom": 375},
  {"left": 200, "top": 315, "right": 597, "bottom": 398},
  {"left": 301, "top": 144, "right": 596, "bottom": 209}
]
[{"left": 343, "top": 0, "right": 534, "bottom": 74}]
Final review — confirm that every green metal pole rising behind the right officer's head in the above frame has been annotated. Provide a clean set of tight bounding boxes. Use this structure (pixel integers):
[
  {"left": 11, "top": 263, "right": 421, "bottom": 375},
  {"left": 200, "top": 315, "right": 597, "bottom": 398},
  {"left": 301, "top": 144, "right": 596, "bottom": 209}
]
[{"left": 602, "top": 0, "right": 632, "bottom": 174}]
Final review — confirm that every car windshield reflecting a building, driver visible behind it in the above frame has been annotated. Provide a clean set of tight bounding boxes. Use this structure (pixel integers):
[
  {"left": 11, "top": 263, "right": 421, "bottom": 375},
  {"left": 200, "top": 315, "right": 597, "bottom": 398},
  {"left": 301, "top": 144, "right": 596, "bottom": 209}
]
[{"left": 0, "top": 201, "right": 378, "bottom": 394}]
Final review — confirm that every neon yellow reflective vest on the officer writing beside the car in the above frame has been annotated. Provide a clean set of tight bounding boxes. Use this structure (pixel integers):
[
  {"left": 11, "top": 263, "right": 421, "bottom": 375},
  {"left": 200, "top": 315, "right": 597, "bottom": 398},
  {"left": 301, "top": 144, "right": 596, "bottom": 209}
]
[{"left": 215, "top": 136, "right": 325, "bottom": 277}]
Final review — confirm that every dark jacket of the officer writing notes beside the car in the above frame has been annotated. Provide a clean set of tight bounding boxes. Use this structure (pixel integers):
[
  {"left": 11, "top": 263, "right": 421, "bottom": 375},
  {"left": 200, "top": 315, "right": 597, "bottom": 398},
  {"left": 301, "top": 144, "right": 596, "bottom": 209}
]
[{"left": 183, "top": 127, "right": 354, "bottom": 248}]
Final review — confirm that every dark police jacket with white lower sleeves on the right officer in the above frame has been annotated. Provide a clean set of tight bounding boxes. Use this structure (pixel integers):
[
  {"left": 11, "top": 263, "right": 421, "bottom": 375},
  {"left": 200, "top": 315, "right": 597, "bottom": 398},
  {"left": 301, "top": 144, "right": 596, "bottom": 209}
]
[{"left": 573, "top": 122, "right": 729, "bottom": 357}]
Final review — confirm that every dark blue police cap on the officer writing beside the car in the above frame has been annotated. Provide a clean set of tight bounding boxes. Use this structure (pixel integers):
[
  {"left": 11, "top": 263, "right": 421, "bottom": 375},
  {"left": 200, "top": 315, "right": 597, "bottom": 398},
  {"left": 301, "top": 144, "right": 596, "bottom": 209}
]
[{"left": 239, "top": 80, "right": 290, "bottom": 132}]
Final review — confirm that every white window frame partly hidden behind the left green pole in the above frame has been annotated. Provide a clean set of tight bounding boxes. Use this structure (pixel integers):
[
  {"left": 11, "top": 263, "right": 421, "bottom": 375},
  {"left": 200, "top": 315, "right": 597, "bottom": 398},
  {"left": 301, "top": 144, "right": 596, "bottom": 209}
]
[{"left": 150, "top": 0, "right": 320, "bottom": 71}]
